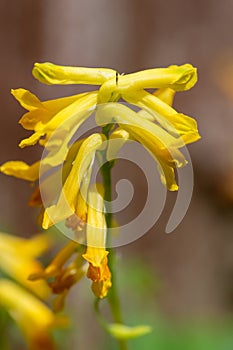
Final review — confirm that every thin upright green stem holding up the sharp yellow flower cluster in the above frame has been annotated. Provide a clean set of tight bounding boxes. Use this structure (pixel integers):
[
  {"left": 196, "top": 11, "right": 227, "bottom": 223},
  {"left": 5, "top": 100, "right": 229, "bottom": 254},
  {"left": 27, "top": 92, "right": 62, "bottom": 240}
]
[{"left": 101, "top": 124, "right": 127, "bottom": 350}]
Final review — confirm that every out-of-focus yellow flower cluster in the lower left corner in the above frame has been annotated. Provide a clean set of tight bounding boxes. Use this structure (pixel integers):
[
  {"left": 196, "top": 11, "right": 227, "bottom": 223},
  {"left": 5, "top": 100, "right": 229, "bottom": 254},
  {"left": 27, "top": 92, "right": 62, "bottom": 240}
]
[{"left": 0, "top": 232, "right": 64, "bottom": 350}]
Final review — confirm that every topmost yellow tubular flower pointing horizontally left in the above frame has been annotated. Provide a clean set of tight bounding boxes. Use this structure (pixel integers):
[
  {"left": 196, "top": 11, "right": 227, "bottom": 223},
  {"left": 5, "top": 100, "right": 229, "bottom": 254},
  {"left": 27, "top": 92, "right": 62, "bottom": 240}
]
[{"left": 32, "top": 62, "right": 116, "bottom": 85}]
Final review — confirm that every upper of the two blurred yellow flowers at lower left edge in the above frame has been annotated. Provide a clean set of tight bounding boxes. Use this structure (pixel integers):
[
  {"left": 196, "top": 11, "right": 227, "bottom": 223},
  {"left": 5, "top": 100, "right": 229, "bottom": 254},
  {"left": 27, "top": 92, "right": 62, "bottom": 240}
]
[{"left": 0, "top": 232, "right": 51, "bottom": 299}]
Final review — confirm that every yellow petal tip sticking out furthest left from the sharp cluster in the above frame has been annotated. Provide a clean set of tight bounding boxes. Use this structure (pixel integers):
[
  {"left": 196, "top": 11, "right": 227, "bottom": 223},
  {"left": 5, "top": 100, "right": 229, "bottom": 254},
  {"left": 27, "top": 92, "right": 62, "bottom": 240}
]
[{"left": 0, "top": 161, "right": 40, "bottom": 181}]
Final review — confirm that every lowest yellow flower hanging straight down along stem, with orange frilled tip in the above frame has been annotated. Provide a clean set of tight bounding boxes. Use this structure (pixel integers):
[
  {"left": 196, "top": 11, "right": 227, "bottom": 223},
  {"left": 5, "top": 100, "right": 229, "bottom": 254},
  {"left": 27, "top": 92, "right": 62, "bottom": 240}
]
[{"left": 83, "top": 185, "right": 112, "bottom": 298}]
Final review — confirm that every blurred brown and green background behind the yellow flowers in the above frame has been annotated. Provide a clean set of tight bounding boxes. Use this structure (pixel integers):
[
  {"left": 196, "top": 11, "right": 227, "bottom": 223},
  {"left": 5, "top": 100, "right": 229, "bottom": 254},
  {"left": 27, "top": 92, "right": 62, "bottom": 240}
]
[{"left": 0, "top": 0, "right": 233, "bottom": 350}]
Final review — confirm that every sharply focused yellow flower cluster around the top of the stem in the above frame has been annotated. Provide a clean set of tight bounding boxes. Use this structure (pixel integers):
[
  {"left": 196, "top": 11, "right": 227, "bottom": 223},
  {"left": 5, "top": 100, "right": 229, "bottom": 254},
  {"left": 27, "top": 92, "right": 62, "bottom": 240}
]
[{"left": 0, "top": 63, "right": 200, "bottom": 309}]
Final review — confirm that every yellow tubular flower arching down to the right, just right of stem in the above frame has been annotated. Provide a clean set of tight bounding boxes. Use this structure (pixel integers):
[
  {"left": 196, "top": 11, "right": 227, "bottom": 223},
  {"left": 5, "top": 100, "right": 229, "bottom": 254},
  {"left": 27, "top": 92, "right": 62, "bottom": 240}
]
[{"left": 96, "top": 103, "right": 186, "bottom": 191}]
